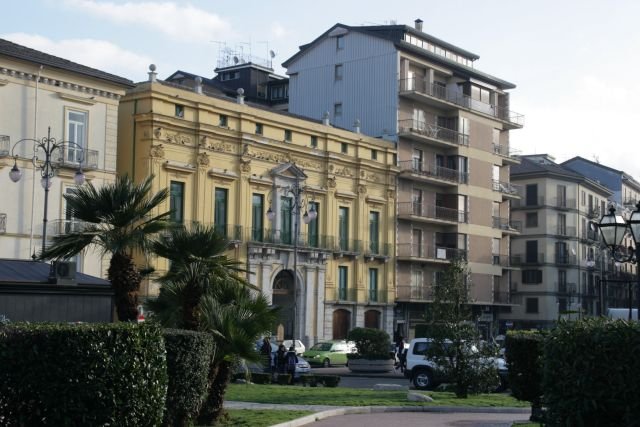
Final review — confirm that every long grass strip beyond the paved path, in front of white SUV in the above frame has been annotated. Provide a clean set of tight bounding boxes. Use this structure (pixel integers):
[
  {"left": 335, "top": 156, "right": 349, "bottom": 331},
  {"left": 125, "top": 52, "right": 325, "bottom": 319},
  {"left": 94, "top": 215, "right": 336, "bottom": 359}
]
[{"left": 225, "top": 384, "right": 530, "bottom": 408}]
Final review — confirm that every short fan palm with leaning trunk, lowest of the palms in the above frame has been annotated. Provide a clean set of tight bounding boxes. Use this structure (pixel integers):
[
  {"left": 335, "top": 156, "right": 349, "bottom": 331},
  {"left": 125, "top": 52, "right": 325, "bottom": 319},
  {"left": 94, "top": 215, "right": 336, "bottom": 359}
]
[{"left": 198, "top": 280, "right": 278, "bottom": 425}]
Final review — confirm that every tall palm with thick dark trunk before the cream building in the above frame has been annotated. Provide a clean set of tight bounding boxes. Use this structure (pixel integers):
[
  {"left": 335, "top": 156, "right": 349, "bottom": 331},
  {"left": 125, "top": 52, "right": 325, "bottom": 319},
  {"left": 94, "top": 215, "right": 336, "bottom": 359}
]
[{"left": 40, "top": 176, "right": 170, "bottom": 321}]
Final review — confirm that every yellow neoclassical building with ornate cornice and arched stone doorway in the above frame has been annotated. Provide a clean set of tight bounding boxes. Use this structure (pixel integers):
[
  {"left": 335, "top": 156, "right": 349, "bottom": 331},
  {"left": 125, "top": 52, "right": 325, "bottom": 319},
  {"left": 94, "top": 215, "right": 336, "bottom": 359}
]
[{"left": 118, "top": 72, "right": 398, "bottom": 345}]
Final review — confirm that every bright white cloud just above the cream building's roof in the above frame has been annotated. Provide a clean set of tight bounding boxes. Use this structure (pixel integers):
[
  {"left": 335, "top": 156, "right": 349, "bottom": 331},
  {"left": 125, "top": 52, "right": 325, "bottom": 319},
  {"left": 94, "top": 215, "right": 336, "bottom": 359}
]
[{"left": 1, "top": 33, "right": 153, "bottom": 78}]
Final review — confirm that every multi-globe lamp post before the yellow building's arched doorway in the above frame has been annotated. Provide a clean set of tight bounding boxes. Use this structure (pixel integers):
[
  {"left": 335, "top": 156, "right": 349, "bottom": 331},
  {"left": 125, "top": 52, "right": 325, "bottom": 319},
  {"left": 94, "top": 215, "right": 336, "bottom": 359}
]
[{"left": 267, "top": 176, "right": 318, "bottom": 347}]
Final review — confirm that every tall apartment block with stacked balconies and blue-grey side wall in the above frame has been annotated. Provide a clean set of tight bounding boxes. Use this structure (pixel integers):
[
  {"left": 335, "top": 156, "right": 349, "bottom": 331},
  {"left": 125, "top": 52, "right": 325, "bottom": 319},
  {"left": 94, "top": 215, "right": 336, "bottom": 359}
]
[{"left": 283, "top": 20, "right": 523, "bottom": 337}]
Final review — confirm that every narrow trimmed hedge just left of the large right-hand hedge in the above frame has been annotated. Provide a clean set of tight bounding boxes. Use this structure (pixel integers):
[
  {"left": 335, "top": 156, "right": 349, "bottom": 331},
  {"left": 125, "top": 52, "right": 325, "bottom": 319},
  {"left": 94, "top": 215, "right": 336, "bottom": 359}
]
[{"left": 505, "top": 331, "right": 544, "bottom": 406}]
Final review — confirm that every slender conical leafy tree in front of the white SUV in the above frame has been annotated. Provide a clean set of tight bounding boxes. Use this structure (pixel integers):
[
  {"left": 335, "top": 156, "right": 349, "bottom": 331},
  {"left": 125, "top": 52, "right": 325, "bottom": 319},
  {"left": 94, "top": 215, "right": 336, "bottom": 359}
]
[{"left": 427, "top": 259, "right": 499, "bottom": 398}]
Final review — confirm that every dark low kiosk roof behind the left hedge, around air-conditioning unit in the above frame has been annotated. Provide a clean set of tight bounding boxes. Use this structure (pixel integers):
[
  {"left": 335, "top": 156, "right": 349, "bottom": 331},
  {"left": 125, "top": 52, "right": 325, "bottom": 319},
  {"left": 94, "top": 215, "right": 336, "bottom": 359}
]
[{"left": 0, "top": 259, "right": 110, "bottom": 286}]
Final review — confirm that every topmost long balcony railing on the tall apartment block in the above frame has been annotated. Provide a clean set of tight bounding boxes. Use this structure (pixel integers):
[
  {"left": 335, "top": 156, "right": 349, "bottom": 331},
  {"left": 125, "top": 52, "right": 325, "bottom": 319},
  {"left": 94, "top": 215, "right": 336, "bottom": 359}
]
[{"left": 400, "top": 77, "right": 524, "bottom": 126}]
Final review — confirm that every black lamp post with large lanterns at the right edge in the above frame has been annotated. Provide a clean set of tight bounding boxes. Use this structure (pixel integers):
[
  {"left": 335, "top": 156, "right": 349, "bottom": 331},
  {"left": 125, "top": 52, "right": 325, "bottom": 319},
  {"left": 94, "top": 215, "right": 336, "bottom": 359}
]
[{"left": 598, "top": 201, "right": 640, "bottom": 320}]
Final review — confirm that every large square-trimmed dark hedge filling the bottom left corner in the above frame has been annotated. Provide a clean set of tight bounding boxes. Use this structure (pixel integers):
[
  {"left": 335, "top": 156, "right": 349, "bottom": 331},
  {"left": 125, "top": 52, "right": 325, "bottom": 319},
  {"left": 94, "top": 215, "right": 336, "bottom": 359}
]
[{"left": 0, "top": 323, "right": 167, "bottom": 426}]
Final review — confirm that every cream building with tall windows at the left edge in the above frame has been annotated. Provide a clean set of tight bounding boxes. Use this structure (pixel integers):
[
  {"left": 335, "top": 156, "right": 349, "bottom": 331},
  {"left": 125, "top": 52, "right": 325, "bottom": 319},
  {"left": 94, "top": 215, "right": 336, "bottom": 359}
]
[{"left": 0, "top": 39, "right": 133, "bottom": 277}]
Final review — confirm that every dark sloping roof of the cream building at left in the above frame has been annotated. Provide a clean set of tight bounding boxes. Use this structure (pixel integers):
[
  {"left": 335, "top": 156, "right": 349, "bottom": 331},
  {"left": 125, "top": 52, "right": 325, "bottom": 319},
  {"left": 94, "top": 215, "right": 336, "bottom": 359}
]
[{"left": 0, "top": 39, "right": 134, "bottom": 87}]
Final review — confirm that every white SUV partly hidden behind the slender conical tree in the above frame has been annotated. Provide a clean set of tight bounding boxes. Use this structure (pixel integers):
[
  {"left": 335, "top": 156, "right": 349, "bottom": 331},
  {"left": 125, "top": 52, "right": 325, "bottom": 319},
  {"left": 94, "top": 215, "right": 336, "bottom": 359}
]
[{"left": 404, "top": 338, "right": 508, "bottom": 390}]
